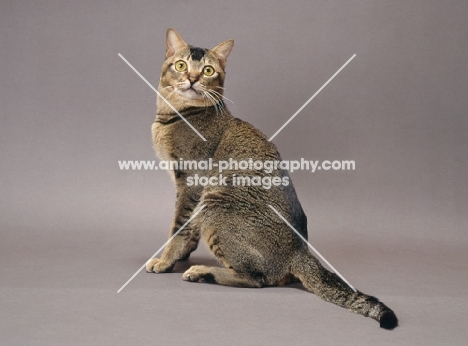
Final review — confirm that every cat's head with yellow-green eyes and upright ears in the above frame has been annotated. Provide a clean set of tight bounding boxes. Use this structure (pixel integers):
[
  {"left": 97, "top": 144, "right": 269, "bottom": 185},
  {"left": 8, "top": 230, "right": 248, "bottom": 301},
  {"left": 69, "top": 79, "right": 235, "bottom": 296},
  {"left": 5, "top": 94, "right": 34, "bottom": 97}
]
[{"left": 158, "top": 29, "right": 234, "bottom": 110}]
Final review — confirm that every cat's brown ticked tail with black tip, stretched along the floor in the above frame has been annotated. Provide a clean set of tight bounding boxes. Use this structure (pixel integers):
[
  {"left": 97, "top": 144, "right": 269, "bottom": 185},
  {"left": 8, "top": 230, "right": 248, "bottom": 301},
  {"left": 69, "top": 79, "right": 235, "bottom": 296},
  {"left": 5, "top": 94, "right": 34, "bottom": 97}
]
[{"left": 291, "top": 251, "right": 398, "bottom": 329}]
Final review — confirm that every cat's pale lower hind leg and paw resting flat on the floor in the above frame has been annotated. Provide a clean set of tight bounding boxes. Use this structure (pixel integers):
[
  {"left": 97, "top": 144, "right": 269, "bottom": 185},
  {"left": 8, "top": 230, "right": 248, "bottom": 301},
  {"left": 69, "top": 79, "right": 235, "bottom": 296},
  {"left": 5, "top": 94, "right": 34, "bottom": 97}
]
[{"left": 182, "top": 265, "right": 263, "bottom": 287}]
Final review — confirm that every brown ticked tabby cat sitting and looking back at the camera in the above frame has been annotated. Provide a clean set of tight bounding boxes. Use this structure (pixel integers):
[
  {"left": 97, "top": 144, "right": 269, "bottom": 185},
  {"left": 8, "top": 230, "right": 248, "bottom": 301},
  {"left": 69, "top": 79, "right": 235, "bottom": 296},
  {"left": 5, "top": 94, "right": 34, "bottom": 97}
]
[{"left": 146, "top": 29, "right": 398, "bottom": 329}]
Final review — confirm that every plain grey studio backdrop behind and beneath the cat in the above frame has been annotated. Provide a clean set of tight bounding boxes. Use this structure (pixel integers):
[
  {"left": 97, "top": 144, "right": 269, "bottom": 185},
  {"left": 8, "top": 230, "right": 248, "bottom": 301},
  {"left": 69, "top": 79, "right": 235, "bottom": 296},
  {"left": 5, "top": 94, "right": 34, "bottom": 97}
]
[{"left": 0, "top": 0, "right": 468, "bottom": 345}]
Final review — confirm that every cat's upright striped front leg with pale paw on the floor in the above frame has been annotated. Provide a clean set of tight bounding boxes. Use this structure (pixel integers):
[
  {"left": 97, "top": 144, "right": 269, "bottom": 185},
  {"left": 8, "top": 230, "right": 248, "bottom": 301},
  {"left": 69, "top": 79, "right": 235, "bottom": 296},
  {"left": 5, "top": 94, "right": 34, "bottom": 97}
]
[{"left": 146, "top": 184, "right": 200, "bottom": 273}]
